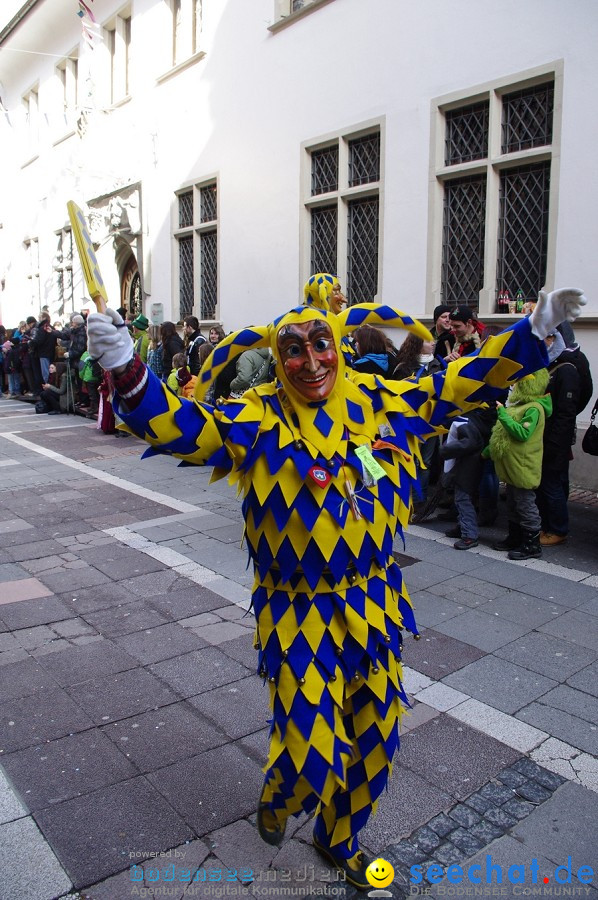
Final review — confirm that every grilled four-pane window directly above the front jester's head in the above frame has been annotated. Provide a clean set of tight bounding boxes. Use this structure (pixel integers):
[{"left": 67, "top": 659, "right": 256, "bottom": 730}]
[{"left": 304, "top": 125, "right": 382, "bottom": 303}]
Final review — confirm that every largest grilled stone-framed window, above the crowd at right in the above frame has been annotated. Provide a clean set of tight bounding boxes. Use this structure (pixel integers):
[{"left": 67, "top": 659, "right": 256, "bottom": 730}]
[{"left": 434, "top": 70, "right": 562, "bottom": 314}]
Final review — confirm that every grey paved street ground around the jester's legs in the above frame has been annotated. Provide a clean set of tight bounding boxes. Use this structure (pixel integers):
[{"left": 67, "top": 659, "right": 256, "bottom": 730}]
[{"left": 0, "top": 399, "right": 598, "bottom": 900}]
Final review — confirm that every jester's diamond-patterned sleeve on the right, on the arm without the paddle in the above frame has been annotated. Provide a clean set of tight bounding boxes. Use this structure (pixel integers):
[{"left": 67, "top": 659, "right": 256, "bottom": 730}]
[{"left": 385, "top": 318, "right": 548, "bottom": 439}]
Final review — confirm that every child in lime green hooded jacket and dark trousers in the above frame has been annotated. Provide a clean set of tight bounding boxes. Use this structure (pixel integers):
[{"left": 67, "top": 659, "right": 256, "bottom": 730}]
[{"left": 484, "top": 369, "right": 552, "bottom": 559}]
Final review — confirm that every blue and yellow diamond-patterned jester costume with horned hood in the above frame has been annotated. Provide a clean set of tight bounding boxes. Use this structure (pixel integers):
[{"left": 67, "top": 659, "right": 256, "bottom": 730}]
[{"left": 115, "top": 304, "right": 546, "bottom": 858}]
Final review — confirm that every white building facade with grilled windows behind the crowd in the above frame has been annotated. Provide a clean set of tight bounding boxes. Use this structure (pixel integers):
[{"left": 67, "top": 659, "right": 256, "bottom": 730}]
[{"left": 0, "top": 0, "right": 598, "bottom": 360}]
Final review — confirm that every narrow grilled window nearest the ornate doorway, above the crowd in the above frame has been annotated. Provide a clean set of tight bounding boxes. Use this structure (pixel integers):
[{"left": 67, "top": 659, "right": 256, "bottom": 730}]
[{"left": 174, "top": 181, "right": 218, "bottom": 322}]
